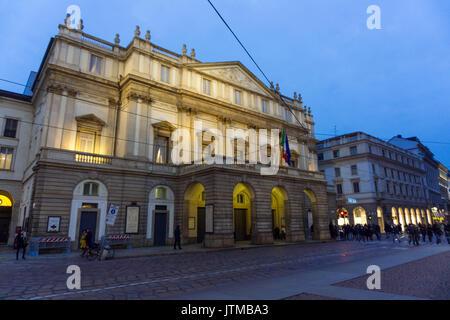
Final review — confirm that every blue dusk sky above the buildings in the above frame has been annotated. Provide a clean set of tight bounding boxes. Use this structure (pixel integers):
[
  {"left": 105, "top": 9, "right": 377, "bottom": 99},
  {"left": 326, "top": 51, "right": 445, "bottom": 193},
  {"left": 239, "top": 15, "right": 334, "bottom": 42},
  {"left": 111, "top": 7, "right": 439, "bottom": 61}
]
[{"left": 0, "top": 0, "right": 450, "bottom": 167}]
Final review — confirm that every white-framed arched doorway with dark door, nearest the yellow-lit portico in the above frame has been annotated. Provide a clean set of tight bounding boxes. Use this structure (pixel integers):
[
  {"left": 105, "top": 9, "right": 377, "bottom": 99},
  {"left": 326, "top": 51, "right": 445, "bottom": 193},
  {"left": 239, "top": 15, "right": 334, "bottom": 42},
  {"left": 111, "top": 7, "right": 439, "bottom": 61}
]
[{"left": 147, "top": 185, "right": 175, "bottom": 246}]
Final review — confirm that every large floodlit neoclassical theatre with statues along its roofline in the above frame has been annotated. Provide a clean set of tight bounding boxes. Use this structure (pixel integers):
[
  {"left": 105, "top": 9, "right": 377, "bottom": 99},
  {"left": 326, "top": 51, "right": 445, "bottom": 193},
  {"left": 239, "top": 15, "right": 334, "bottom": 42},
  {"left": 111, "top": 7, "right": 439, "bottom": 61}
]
[{"left": 0, "top": 18, "right": 329, "bottom": 247}]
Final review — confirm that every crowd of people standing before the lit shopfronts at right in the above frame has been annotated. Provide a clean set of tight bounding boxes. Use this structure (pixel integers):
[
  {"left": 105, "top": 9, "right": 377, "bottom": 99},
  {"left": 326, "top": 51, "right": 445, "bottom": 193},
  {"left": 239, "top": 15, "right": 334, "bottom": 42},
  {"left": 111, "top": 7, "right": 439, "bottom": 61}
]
[{"left": 330, "top": 222, "right": 450, "bottom": 246}]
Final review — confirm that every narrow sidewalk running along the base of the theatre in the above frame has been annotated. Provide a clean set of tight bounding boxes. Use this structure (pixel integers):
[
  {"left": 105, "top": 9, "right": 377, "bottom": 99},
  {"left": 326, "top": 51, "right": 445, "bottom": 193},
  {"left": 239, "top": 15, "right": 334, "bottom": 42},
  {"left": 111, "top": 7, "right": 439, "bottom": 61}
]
[{"left": 0, "top": 240, "right": 334, "bottom": 263}]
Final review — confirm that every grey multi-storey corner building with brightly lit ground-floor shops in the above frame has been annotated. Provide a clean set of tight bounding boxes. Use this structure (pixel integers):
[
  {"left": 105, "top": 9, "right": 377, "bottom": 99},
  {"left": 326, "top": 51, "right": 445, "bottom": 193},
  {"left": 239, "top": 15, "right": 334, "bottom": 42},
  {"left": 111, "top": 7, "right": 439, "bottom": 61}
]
[{"left": 317, "top": 132, "right": 432, "bottom": 230}]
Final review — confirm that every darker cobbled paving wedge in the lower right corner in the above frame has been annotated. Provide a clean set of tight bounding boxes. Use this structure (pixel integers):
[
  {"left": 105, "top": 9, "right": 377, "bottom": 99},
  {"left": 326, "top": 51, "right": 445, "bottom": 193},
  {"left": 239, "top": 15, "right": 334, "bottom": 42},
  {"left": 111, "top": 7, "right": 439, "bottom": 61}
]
[{"left": 335, "top": 251, "right": 450, "bottom": 300}]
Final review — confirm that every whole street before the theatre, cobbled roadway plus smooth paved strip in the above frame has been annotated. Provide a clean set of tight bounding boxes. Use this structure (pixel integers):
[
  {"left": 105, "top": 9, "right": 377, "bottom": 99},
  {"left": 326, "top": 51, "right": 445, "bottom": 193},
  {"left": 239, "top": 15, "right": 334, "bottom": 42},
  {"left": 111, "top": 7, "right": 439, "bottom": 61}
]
[{"left": 0, "top": 241, "right": 450, "bottom": 299}]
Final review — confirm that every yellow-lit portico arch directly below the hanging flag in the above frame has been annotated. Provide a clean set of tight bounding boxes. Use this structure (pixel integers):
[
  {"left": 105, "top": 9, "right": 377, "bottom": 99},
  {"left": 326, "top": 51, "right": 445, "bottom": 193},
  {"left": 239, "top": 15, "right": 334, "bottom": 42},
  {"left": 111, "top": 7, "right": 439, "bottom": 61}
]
[{"left": 271, "top": 187, "right": 288, "bottom": 240}]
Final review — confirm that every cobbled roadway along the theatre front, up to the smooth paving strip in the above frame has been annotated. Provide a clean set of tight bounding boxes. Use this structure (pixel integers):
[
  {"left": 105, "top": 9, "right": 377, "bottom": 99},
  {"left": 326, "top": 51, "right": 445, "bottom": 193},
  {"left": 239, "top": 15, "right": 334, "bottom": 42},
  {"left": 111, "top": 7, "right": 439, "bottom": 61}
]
[{"left": 0, "top": 241, "right": 442, "bottom": 300}]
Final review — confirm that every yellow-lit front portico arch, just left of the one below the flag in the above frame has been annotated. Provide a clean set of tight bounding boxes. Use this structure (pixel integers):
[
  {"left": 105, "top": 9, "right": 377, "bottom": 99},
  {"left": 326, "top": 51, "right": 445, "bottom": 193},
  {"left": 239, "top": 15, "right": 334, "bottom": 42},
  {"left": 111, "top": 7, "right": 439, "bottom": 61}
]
[{"left": 233, "top": 183, "right": 254, "bottom": 241}]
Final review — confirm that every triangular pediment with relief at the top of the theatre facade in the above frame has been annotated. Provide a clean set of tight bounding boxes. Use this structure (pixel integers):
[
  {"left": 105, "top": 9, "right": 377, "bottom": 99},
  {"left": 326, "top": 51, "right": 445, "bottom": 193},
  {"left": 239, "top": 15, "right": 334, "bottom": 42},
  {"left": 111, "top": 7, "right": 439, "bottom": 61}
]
[{"left": 191, "top": 62, "right": 272, "bottom": 96}]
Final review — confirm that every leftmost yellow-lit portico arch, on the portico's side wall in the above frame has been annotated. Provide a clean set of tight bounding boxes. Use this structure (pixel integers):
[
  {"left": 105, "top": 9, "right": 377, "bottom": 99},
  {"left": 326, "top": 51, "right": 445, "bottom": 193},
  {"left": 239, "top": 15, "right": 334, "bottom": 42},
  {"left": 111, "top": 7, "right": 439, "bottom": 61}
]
[{"left": 184, "top": 182, "right": 206, "bottom": 243}]
